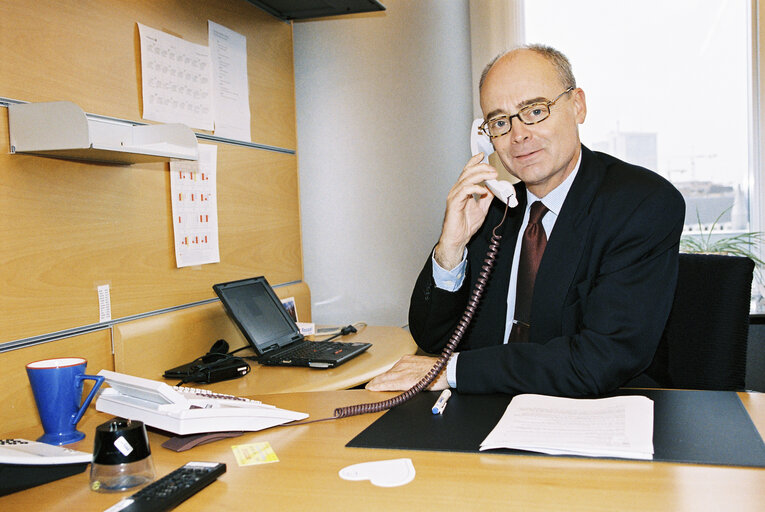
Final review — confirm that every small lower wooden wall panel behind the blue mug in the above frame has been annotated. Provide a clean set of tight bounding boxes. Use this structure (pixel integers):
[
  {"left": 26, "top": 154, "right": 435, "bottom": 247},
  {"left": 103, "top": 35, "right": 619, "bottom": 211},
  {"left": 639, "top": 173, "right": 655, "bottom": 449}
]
[{"left": 0, "top": 329, "right": 114, "bottom": 435}]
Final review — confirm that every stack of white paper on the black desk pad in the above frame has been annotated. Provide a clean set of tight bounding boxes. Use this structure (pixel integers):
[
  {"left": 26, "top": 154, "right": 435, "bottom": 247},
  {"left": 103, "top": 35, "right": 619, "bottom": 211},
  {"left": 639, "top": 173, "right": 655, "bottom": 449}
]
[{"left": 481, "top": 395, "right": 653, "bottom": 459}]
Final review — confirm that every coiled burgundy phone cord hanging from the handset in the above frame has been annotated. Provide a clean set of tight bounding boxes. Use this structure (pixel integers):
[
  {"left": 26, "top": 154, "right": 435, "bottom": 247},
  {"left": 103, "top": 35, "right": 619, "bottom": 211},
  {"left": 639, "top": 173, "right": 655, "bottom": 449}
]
[{"left": 332, "top": 200, "right": 509, "bottom": 419}]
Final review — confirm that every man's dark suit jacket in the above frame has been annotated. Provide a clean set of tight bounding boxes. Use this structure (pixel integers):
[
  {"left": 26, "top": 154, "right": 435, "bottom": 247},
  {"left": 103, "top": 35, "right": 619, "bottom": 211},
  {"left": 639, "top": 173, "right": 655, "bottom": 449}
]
[{"left": 409, "top": 146, "right": 685, "bottom": 396}]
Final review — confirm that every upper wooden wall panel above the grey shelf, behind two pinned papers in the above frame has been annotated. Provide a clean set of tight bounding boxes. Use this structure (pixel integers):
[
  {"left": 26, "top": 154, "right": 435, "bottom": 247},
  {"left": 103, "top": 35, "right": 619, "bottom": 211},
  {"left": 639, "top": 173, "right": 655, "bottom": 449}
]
[{"left": 0, "top": 0, "right": 297, "bottom": 150}]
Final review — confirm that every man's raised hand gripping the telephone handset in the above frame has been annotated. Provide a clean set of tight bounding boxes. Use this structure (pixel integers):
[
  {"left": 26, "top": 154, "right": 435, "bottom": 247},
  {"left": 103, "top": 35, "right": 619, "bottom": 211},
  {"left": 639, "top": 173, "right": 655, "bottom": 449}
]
[{"left": 434, "top": 153, "right": 497, "bottom": 270}]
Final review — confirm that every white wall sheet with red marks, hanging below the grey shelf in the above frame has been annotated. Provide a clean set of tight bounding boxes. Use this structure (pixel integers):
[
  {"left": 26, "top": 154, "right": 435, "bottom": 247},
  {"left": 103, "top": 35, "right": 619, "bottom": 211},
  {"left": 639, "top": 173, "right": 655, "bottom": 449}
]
[{"left": 170, "top": 144, "right": 220, "bottom": 268}]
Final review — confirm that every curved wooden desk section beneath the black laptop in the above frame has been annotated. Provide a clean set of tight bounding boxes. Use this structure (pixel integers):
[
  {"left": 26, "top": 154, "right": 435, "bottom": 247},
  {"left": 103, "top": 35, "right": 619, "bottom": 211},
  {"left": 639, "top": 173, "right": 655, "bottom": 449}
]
[{"left": 161, "top": 326, "right": 417, "bottom": 396}]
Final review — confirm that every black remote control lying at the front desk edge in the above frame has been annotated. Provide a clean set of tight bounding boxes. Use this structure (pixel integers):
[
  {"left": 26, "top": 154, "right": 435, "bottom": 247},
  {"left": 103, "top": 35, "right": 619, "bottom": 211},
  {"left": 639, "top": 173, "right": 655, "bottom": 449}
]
[{"left": 106, "top": 462, "right": 226, "bottom": 512}]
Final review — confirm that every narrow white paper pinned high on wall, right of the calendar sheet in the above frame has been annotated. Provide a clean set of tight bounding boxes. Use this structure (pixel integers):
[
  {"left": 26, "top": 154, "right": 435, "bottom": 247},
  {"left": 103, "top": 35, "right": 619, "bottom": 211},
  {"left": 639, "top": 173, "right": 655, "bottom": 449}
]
[{"left": 207, "top": 20, "right": 252, "bottom": 142}]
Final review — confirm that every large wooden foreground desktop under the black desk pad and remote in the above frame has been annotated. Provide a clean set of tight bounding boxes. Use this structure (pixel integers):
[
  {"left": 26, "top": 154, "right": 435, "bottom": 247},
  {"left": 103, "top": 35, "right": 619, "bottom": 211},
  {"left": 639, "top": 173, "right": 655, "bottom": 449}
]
[{"left": 0, "top": 390, "right": 765, "bottom": 512}]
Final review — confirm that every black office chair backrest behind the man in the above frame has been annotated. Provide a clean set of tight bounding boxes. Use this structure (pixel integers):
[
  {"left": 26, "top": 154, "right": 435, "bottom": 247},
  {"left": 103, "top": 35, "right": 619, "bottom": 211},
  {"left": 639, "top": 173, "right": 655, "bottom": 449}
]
[{"left": 646, "top": 254, "right": 754, "bottom": 390}]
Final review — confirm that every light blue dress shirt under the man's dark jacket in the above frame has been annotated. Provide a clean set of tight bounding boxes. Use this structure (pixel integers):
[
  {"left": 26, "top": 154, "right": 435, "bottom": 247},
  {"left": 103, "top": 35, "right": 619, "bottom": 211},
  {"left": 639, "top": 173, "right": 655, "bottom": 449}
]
[{"left": 431, "top": 152, "right": 582, "bottom": 388}]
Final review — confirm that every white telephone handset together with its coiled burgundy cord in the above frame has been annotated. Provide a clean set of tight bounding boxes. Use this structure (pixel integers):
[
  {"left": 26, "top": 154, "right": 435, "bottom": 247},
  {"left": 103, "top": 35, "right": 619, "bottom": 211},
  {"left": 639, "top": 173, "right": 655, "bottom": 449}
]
[{"left": 326, "top": 119, "right": 518, "bottom": 418}]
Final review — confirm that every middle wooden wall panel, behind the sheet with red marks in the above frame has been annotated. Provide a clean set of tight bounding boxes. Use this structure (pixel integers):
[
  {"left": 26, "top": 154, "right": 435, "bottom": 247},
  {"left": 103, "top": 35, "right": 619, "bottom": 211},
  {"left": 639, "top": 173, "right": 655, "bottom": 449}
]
[{"left": 0, "top": 109, "right": 302, "bottom": 342}]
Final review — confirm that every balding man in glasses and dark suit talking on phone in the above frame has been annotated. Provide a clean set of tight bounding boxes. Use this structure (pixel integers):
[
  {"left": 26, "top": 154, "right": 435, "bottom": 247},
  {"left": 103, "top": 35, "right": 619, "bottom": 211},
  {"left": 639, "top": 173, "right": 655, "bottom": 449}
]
[{"left": 367, "top": 46, "right": 685, "bottom": 396}]
